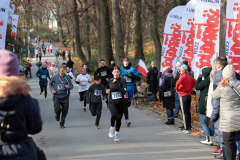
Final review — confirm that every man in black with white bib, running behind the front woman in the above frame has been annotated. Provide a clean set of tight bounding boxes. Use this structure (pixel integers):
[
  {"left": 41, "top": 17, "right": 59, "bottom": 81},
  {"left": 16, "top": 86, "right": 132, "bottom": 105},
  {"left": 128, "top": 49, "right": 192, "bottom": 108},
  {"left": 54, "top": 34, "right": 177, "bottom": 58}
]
[{"left": 94, "top": 59, "right": 111, "bottom": 104}]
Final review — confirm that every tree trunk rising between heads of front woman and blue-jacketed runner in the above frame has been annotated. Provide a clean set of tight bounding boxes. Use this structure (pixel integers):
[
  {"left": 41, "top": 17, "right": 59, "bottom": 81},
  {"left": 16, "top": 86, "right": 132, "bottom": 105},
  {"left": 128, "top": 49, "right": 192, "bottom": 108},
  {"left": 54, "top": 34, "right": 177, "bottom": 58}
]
[{"left": 112, "top": 0, "right": 124, "bottom": 65}]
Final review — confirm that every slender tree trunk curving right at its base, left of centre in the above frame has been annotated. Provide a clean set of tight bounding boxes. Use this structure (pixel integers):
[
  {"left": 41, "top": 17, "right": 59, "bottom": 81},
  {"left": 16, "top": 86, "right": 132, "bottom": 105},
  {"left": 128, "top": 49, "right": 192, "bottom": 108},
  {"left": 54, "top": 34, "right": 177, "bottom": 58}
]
[{"left": 72, "top": 0, "right": 86, "bottom": 62}]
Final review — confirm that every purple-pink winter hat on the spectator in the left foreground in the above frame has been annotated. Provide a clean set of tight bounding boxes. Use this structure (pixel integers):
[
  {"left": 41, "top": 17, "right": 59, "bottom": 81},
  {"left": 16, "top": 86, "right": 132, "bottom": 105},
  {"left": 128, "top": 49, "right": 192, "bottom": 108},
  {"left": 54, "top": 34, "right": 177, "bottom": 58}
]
[{"left": 0, "top": 50, "right": 19, "bottom": 76}]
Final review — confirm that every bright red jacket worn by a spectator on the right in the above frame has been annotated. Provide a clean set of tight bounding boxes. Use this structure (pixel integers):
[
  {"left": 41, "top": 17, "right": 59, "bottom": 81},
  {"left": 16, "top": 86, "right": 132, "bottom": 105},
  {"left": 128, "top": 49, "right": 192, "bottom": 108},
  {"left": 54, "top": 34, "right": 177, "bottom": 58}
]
[{"left": 176, "top": 72, "right": 196, "bottom": 97}]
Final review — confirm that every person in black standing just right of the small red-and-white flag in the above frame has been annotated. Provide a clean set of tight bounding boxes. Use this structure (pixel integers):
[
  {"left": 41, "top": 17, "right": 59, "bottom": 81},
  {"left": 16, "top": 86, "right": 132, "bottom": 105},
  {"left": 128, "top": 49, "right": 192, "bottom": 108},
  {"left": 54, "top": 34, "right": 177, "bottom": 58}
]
[{"left": 147, "top": 61, "right": 158, "bottom": 101}]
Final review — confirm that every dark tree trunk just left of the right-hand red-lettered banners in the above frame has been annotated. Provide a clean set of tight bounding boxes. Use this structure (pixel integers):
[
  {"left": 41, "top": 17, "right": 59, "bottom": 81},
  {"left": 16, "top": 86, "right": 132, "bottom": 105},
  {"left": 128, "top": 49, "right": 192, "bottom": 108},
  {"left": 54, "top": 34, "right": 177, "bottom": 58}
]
[{"left": 151, "top": 0, "right": 162, "bottom": 70}]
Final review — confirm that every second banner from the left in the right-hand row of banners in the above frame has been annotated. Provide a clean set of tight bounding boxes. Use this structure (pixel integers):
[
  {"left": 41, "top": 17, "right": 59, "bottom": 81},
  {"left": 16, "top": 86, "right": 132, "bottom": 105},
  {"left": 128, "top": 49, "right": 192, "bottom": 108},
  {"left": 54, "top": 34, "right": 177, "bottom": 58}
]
[{"left": 177, "top": 0, "right": 197, "bottom": 74}]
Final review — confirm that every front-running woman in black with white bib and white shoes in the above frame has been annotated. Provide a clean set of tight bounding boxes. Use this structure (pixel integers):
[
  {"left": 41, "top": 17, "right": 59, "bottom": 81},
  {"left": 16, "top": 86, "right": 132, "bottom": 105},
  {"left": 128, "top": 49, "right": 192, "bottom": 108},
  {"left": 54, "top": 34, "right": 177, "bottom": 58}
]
[{"left": 106, "top": 66, "right": 127, "bottom": 142}]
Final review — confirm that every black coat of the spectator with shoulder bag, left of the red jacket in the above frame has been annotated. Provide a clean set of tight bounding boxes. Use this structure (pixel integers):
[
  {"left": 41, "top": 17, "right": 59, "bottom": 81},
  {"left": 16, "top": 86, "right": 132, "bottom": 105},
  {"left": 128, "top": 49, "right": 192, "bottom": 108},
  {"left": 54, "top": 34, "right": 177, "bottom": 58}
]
[{"left": 160, "top": 75, "right": 175, "bottom": 109}]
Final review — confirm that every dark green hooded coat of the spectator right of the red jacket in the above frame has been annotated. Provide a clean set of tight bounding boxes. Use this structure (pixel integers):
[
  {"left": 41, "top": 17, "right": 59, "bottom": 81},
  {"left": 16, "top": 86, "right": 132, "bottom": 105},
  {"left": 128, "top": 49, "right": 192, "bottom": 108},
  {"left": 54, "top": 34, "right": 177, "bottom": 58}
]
[{"left": 195, "top": 67, "right": 212, "bottom": 114}]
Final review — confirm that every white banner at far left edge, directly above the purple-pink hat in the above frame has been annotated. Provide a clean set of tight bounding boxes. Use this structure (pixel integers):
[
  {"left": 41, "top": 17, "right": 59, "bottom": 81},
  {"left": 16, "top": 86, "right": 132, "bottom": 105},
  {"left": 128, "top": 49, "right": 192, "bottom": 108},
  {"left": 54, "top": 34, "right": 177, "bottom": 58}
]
[{"left": 0, "top": 0, "right": 10, "bottom": 49}]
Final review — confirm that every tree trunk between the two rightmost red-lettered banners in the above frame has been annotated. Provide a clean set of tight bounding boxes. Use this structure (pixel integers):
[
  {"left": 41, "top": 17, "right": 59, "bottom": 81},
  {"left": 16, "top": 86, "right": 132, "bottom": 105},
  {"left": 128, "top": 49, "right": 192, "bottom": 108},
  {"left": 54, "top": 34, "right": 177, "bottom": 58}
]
[{"left": 219, "top": 0, "right": 227, "bottom": 56}]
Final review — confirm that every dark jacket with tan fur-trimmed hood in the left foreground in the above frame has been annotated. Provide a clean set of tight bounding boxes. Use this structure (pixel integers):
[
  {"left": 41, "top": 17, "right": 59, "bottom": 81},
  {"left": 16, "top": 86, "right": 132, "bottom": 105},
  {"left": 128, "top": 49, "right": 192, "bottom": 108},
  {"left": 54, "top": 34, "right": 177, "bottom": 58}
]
[{"left": 0, "top": 76, "right": 42, "bottom": 160}]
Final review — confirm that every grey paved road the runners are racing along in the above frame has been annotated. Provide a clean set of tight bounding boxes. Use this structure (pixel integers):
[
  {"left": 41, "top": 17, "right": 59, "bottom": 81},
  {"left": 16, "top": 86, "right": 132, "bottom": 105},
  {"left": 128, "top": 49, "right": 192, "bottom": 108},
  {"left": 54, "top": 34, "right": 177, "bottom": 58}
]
[{"left": 28, "top": 43, "right": 214, "bottom": 160}]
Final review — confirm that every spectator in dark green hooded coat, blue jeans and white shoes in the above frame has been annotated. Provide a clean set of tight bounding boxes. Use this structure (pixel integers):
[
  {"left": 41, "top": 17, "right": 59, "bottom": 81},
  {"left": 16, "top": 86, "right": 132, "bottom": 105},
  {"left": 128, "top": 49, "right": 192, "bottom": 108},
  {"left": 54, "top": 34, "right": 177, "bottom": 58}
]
[{"left": 195, "top": 67, "right": 214, "bottom": 145}]
